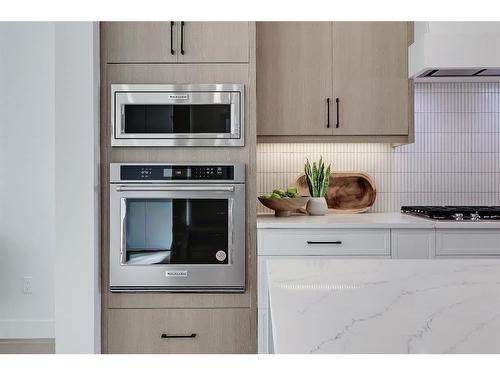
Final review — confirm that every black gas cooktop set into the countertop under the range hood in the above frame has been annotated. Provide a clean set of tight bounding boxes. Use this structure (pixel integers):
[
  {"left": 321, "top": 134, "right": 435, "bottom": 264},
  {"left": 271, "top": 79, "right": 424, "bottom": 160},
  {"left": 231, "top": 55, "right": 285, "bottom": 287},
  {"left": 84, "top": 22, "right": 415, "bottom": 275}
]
[{"left": 401, "top": 206, "right": 500, "bottom": 221}]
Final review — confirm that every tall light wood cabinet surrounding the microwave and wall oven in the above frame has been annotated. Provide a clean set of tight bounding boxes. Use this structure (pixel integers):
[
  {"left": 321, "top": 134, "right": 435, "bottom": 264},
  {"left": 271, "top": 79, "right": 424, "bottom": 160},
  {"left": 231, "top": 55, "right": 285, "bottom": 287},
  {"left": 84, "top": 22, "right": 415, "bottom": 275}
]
[{"left": 100, "top": 22, "right": 257, "bottom": 353}]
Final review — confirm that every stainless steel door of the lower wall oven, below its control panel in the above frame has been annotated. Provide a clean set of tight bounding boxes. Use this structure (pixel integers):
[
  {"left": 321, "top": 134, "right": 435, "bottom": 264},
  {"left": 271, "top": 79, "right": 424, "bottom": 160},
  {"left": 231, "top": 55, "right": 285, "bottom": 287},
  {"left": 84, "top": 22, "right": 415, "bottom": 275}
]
[{"left": 109, "top": 184, "right": 245, "bottom": 292}]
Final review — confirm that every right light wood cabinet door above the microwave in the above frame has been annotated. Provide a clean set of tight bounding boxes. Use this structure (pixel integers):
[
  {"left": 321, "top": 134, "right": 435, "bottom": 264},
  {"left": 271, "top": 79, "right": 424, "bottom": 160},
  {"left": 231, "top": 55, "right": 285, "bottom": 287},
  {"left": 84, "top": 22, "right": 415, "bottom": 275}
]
[{"left": 178, "top": 22, "right": 249, "bottom": 62}]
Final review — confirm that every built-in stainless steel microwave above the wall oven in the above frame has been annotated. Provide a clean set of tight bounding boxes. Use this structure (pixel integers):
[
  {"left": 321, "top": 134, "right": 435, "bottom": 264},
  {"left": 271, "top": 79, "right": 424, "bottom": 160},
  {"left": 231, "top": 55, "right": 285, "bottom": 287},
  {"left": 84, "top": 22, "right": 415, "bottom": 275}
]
[{"left": 110, "top": 84, "right": 244, "bottom": 146}]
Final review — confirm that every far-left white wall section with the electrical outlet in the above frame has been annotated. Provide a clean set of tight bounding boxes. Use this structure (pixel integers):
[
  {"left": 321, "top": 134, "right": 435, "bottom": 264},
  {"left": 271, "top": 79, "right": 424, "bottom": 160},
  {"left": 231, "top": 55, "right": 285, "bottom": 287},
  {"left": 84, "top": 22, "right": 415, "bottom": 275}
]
[{"left": 0, "top": 23, "right": 55, "bottom": 338}]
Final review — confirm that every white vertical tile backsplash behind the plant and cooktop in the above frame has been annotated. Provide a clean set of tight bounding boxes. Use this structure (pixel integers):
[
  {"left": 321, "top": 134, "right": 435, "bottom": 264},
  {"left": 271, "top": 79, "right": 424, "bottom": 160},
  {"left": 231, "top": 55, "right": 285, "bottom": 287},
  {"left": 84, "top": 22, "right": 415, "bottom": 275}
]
[{"left": 257, "top": 82, "right": 500, "bottom": 212}]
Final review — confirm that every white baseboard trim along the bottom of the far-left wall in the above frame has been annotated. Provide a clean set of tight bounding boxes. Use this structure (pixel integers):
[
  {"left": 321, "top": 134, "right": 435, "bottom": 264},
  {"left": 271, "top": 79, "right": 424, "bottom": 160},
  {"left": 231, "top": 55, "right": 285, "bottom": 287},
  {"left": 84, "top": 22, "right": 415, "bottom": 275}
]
[{"left": 0, "top": 319, "right": 55, "bottom": 339}]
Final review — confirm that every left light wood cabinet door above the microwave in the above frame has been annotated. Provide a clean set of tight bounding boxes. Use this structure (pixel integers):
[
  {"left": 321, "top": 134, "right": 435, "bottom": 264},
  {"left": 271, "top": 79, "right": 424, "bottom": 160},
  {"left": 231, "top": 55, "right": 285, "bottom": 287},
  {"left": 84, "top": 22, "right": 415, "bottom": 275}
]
[{"left": 101, "top": 22, "right": 180, "bottom": 63}]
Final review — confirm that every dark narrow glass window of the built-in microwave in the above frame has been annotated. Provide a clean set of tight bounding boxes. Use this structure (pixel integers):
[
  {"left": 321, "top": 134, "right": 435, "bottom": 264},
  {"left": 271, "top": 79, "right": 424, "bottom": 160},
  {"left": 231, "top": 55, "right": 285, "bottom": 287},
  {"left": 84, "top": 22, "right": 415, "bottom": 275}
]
[{"left": 124, "top": 104, "right": 231, "bottom": 134}]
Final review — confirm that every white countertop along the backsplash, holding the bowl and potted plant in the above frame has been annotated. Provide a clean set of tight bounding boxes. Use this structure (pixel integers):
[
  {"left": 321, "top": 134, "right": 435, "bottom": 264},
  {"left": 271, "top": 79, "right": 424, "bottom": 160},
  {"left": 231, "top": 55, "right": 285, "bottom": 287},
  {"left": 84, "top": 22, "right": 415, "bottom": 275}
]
[{"left": 257, "top": 212, "right": 500, "bottom": 229}]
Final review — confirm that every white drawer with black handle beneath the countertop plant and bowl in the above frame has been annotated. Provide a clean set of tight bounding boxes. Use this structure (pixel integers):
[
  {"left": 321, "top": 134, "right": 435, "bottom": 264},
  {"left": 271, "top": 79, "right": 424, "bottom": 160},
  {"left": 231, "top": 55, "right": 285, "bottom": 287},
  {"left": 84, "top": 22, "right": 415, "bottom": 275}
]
[{"left": 257, "top": 229, "right": 391, "bottom": 256}]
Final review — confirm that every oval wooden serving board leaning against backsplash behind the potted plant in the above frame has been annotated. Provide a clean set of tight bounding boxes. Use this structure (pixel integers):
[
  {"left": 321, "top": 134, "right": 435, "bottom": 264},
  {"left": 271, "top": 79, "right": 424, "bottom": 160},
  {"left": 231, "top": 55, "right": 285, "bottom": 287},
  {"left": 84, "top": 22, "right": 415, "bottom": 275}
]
[{"left": 297, "top": 171, "right": 377, "bottom": 214}]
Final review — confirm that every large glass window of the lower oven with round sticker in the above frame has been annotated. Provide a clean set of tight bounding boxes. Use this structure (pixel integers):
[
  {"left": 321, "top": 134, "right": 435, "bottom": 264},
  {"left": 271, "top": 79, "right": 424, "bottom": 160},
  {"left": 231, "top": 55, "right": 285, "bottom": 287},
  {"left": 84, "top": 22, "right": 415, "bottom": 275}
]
[{"left": 123, "top": 199, "right": 229, "bottom": 265}]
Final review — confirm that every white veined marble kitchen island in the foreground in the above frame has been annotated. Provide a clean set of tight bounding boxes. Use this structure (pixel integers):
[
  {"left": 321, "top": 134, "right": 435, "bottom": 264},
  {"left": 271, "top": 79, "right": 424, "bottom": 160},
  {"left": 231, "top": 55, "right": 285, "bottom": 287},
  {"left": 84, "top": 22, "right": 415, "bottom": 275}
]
[{"left": 267, "top": 257, "right": 500, "bottom": 353}]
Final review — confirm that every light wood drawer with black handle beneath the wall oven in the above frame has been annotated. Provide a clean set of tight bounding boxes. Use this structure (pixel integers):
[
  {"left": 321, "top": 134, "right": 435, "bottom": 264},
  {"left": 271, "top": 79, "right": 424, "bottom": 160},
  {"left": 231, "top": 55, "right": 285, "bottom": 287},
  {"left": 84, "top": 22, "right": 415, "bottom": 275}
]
[{"left": 108, "top": 309, "right": 251, "bottom": 354}]
